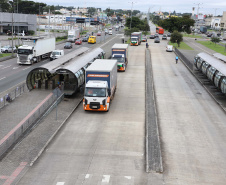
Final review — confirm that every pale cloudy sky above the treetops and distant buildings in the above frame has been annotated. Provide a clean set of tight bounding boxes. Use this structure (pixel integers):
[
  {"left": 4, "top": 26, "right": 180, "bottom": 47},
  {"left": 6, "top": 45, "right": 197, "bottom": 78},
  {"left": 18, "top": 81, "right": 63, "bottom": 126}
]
[{"left": 38, "top": 0, "right": 226, "bottom": 15}]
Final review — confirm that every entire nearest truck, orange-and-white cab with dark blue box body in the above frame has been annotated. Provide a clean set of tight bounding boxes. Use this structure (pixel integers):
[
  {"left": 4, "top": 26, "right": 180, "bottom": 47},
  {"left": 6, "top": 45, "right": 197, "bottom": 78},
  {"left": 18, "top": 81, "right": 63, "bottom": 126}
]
[{"left": 83, "top": 59, "right": 117, "bottom": 111}]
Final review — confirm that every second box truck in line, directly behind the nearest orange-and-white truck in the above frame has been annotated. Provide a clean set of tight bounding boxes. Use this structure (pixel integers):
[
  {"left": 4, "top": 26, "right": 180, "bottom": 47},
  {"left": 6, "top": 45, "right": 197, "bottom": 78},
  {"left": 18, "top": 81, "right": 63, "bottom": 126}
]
[{"left": 111, "top": 44, "right": 129, "bottom": 71}]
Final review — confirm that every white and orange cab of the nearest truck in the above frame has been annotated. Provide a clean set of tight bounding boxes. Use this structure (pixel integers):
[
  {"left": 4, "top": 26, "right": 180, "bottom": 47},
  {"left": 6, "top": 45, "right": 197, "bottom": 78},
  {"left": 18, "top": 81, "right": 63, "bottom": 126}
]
[{"left": 83, "top": 81, "right": 111, "bottom": 111}]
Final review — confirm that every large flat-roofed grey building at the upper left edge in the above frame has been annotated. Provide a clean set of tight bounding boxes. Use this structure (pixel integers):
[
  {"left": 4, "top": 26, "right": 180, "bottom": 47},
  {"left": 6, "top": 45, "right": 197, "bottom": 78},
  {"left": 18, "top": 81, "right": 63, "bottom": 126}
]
[{"left": 0, "top": 12, "right": 37, "bottom": 33}]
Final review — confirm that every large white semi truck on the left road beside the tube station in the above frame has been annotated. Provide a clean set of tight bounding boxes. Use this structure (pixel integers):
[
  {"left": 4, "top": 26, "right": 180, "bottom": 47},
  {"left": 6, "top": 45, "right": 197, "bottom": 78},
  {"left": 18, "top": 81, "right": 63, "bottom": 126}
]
[{"left": 17, "top": 37, "right": 56, "bottom": 64}]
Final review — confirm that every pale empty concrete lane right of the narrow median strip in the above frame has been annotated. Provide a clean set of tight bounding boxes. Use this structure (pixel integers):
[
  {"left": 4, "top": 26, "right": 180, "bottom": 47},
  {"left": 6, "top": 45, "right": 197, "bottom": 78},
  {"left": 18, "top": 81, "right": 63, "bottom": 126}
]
[{"left": 150, "top": 33, "right": 226, "bottom": 185}]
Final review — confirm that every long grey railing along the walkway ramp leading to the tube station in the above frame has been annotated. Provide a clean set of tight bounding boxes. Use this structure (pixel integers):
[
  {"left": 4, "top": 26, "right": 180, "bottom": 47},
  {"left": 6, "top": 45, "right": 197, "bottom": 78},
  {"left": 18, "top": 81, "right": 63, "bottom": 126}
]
[{"left": 0, "top": 88, "right": 64, "bottom": 157}]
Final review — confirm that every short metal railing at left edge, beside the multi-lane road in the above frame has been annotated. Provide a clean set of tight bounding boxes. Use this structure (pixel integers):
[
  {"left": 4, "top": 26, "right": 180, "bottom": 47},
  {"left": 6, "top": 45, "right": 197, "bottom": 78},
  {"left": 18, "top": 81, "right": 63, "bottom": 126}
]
[{"left": 0, "top": 83, "right": 28, "bottom": 110}]
